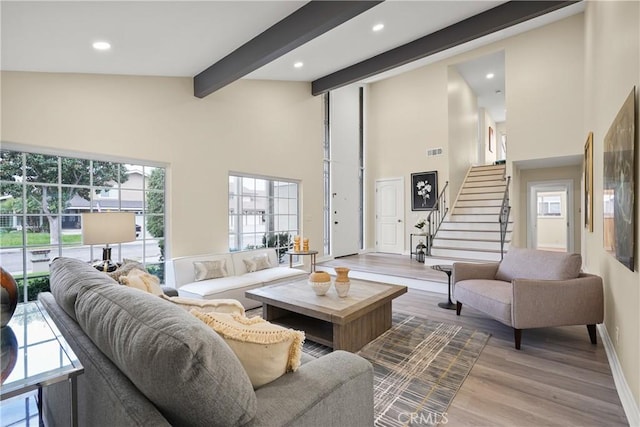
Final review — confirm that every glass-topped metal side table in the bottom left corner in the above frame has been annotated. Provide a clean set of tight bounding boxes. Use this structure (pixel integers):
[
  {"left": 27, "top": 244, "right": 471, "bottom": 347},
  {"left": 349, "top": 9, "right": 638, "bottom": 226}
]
[{"left": 0, "top": 302, "right": 84, "bottom": 426}]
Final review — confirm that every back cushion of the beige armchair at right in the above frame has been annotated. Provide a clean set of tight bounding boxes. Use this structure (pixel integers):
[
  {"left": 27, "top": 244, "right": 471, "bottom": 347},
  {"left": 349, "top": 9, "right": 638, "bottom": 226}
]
[{"left": 496, "top": 248, "right": 582, "bottom": 282}]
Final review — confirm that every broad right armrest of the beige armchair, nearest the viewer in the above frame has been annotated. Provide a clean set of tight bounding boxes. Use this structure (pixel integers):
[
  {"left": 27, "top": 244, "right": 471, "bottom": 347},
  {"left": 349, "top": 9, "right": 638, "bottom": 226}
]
[{"left": 511, "top": 273, "right": 604, "bottom": 329}]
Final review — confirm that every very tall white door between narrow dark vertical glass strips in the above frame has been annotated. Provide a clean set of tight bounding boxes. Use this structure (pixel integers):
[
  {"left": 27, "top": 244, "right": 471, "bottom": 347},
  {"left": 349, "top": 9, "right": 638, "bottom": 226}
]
[{"left": 329, "top": 85, "right": 362, "bottom": 257}]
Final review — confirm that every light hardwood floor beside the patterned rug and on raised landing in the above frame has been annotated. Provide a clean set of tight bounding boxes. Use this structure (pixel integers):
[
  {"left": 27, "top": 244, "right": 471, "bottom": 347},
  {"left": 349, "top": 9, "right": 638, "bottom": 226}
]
[{"left": 318, "top": 254, "right": 628, "bottom": 427}]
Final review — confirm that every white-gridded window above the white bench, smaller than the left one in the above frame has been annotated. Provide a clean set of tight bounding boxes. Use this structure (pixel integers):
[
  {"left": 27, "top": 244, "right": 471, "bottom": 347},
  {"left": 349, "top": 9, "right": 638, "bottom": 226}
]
[{"left": 229, "top": 174, "right": 300, "bottom": 262}]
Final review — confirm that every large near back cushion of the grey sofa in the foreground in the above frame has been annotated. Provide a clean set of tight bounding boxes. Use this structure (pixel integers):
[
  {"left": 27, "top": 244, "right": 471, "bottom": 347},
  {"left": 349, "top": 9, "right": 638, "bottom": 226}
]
[{"left": 74, "top": 282, "right": 257, "bottom": 426}]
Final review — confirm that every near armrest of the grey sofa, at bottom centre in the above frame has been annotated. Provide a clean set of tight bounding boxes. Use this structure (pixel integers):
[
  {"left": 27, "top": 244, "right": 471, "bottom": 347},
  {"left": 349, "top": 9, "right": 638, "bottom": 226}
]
[{"left": 249, "top": 351, "right": 374, "bottom": 427}]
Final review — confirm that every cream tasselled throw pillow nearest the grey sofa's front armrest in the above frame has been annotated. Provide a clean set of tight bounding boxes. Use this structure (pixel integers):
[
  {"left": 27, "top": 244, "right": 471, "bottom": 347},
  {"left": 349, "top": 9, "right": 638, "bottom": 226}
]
[{"left": 191, "top": 310, "right": 304, "bottom": 388}]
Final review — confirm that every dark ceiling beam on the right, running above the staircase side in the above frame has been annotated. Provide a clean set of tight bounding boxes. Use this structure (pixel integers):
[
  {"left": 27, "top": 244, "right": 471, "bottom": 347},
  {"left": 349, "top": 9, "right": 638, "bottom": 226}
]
[{"left": 311, "top": 0, "right": 578, "bottom": 95}]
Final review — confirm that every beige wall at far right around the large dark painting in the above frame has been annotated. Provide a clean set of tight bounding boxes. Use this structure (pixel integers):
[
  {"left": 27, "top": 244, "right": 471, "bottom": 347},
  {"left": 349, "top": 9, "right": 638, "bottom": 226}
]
[{"left": 582, "top": 1, "right": 640, "bottom": 406}]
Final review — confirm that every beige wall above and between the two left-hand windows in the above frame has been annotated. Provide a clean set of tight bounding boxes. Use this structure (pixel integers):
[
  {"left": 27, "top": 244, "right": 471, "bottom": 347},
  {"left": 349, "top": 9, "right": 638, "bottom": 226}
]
[{"left": 2, "top": 72, "right": 323, "bottom": 256}]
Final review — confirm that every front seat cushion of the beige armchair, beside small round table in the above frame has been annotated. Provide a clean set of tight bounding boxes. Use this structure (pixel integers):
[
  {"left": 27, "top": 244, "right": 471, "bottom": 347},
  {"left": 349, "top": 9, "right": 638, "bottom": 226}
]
[{"left": 453, "top": 279, "right": 512, "bottom": 325}]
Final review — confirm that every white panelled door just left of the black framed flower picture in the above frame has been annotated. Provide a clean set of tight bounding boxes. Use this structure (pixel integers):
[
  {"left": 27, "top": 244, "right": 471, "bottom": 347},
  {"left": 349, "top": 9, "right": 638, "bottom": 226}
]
[{"left": 375, "top": 178, "right": 405, "bottom": 254}]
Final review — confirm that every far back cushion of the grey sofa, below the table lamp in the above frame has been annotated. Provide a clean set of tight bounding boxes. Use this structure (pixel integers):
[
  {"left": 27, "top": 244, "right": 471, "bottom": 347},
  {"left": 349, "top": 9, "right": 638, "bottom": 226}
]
[{"left": 49, "top": 257, "right": 118, "bottom": 320}]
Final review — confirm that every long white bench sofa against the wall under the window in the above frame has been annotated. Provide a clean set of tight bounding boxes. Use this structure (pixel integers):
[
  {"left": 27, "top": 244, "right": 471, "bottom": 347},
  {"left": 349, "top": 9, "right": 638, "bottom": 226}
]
[{"left": 167, "top": 248, "right": 307, "bottom": 309}]
